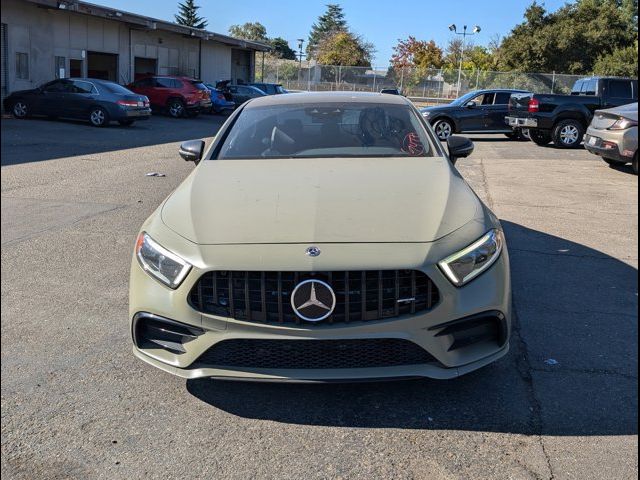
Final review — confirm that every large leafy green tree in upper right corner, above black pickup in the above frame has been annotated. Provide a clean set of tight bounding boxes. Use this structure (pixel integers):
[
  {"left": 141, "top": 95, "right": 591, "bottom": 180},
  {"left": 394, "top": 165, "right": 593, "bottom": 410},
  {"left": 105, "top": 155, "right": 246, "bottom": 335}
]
[{"left": 498, "top": 0, "right": 638, "bottom": 75}]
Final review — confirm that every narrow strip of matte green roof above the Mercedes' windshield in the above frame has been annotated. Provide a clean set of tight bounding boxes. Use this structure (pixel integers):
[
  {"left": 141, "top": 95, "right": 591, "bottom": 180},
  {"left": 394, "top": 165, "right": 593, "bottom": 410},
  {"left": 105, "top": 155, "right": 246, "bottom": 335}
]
[{"left": 246, "top": 92, "right": 410, "bottom": 108}]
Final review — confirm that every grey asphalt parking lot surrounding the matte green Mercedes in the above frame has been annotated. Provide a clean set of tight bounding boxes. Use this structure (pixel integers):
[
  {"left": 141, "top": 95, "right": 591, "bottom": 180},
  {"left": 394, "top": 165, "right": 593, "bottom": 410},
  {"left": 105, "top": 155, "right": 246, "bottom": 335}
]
[{"left": 1, "top": 116, "right": 638, "bottom": 479}]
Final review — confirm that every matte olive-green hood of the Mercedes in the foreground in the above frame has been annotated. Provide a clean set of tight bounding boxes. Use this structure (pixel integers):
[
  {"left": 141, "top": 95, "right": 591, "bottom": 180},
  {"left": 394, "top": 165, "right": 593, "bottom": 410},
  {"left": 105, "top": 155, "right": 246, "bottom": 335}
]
[{"left": 161, "top": 157, "right": 481, "bottom": 245}]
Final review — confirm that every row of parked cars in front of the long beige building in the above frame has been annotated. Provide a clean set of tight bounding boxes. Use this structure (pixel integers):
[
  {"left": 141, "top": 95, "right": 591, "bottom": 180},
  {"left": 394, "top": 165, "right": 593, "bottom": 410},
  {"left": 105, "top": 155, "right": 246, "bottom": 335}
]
[{"left": 3, "top": 75, "right": 288, "bottom": 127}]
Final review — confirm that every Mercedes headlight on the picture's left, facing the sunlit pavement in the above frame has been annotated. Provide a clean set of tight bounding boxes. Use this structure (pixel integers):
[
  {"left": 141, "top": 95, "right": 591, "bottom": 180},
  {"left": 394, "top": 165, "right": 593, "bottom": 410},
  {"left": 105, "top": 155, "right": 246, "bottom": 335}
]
[{"left": 136, "top": 232, "right": 191, "bottom": 289}]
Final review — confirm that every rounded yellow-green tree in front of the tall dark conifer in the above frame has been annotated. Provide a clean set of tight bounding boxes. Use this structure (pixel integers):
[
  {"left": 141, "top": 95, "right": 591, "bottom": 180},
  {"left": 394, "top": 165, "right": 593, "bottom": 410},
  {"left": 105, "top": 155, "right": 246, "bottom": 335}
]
[{"left": 317, "top": 31, "right": 374, "bottom": 67}]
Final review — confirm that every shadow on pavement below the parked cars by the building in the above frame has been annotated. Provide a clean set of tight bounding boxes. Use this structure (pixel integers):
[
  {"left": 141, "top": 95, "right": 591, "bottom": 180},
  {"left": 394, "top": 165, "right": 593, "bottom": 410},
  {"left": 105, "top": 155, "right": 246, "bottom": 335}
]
[{"left": 1, "top": 114, "right": 227, "bottom": 166}]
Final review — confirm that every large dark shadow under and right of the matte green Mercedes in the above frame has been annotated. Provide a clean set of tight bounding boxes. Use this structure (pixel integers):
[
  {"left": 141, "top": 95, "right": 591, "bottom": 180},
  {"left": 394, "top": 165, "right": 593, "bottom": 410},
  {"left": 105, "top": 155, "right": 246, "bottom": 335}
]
[{"left": 187, "top": 222, "right": 638, "bottom": 435}]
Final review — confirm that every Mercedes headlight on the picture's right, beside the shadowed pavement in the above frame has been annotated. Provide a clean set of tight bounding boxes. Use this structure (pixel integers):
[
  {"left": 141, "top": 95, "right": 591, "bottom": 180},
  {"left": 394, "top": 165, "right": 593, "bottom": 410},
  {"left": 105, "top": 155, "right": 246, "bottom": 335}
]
[{"left": 438, "top": 230, "right": 504, "bottom": 287}]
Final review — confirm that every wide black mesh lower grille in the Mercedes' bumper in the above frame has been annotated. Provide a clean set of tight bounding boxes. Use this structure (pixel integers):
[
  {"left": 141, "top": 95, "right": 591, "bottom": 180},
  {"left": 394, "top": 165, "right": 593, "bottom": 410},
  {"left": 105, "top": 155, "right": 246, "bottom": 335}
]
[{"left": 197, "top": 338, "right": 436, "bottom": 369}]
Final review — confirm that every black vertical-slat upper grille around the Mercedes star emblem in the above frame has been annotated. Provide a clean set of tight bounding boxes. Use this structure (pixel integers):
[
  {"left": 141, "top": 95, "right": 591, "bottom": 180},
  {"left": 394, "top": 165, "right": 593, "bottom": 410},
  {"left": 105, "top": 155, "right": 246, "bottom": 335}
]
[{"left": 189, "top": 270, "right": 440, "bottom": 324}]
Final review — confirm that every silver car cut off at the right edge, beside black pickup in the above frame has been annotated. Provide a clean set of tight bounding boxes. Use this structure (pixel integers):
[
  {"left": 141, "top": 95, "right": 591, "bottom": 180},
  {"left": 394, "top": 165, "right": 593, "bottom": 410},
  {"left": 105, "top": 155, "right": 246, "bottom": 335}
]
[{"left": 584, "top": 102, "right": 638, "bottom": 175}]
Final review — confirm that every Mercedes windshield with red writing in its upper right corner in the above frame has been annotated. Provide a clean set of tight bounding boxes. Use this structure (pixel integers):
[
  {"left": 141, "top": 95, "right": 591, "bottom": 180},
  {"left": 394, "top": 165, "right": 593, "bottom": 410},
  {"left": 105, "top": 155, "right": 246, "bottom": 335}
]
[{"left": 218, "top": 103, "right": 434, "bottom": 160}]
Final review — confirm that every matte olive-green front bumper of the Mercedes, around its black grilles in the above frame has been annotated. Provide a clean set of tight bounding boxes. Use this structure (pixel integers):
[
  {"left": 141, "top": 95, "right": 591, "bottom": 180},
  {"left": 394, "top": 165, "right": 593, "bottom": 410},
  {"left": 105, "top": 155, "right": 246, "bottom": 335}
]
[{"left": 130, "top": 237, "right": 511, "bottom": 382}]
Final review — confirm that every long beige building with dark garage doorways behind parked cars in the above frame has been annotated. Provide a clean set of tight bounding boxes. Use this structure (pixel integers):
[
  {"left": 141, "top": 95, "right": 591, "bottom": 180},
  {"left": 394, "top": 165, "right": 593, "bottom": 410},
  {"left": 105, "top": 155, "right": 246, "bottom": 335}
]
[{"left": 1, "top": 0, "right": 270, "bottom": 98}]
